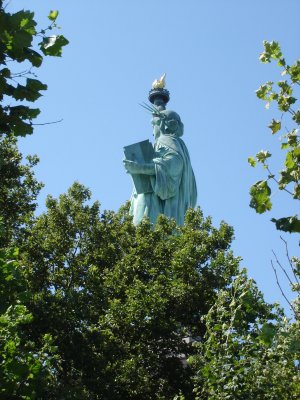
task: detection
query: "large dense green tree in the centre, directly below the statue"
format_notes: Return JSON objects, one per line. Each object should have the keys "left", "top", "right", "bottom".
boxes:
{"left": 17, "top": 183, "right": 248, "bottom": 400}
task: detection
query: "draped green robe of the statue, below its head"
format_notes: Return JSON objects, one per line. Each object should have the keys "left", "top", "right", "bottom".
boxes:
{"left": 130, "top": 135, "right": 197, "bottom": 225}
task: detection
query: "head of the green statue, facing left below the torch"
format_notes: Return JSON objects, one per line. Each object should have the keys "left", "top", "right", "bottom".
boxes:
{"left": 152, "top": 110, "right": 184, "bottom": 139}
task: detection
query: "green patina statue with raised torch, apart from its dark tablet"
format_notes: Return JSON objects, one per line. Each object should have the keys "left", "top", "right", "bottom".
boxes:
{"left": 123, "top": 75, "right": 197, "bottom": 225}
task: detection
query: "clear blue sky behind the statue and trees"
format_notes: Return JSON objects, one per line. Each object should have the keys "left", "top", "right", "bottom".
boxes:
{"left": 9, "top": 0, "right": 300, "bottom": 312}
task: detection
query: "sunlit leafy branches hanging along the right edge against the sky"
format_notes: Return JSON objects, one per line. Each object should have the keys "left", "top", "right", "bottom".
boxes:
{"left": 248, "top": 41, "right": 300, "bottom": 232}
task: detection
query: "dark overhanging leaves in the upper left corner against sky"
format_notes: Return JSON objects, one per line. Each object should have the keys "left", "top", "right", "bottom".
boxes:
{"left": 0, "top": 1, "right": 68, "bottom": 136}
